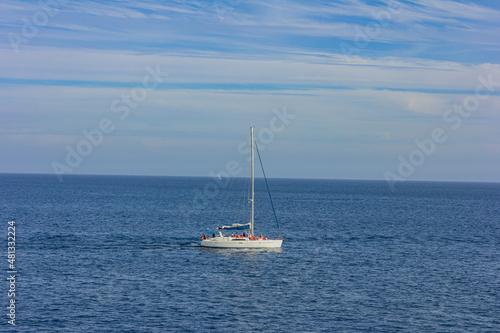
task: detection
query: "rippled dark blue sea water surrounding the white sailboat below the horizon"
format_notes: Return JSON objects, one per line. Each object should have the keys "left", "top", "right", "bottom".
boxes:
{"left": 0, "top": 174, "right": 500, "bottom": 332}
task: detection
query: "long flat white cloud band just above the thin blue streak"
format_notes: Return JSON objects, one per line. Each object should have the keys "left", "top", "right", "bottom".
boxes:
{"left": 0, "top": 47, "right": 500, "bottom": 91}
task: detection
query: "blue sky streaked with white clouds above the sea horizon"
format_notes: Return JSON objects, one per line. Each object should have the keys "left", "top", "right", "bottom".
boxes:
{"left": 0, "top": 0, "right": 500, "bottom": 183}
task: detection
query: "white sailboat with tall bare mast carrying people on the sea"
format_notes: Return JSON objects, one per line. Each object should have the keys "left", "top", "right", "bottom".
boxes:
{"left": 200, "top": 127, "right": 283, "bottom": 249}
